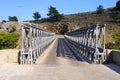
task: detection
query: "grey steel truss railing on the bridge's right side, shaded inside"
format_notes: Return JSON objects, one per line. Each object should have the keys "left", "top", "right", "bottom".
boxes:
{"left": 64, "top": 24, "right": 106, "bottom": 64}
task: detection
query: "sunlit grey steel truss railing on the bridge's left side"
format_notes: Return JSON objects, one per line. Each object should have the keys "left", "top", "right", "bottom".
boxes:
{"left": 20, "top": 25, "right": 55, "bottom": 64}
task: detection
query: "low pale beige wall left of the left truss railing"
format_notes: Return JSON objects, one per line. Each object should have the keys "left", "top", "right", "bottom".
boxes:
{"left": 0, "top": 49, "right": 19, "bottom": 64}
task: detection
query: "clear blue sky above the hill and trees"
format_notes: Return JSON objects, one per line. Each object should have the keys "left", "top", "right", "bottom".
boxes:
{"left": 0, "top": 0, "right": 118, "bottom": 21}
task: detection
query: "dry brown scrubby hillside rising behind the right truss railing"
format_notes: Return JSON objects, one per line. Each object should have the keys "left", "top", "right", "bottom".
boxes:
{"left": 62, "top": 8, "right": 120, "bottom": 42}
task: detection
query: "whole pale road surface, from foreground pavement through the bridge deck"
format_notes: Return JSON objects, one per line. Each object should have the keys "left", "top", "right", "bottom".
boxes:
{"left": 0, "top": 36, "right": 120, "bottom": 80}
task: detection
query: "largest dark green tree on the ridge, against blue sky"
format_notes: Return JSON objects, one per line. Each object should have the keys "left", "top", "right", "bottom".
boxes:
{"left": 47, "top": 6, "right": 63, "bottom": 22}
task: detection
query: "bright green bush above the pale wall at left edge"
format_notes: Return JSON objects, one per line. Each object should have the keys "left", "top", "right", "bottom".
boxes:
{"left": 0, "top": 32, "right": 20, "bottom": 49}
